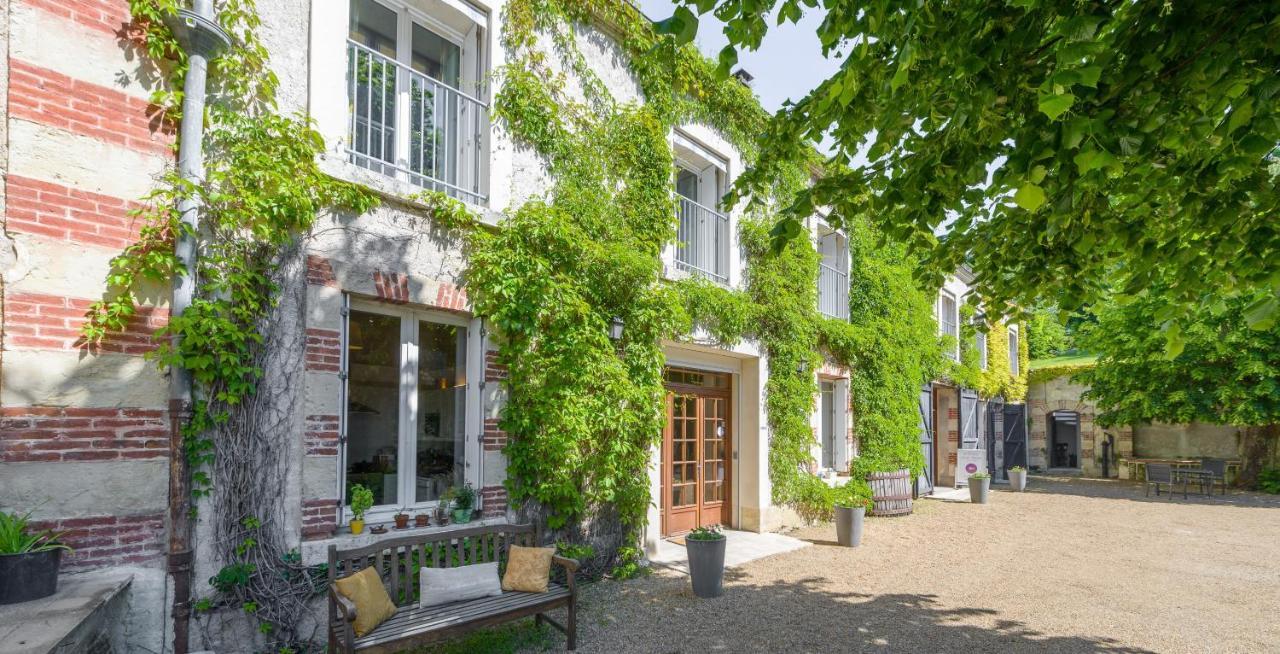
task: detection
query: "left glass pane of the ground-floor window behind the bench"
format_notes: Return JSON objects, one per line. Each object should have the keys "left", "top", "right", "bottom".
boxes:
{"left": 347, "top": 311, "right": 401, "bottom": 504}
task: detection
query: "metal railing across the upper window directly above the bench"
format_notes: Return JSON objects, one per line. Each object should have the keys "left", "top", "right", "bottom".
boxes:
{"left": 347, "top": 41, "right": 489, "bottom": 205}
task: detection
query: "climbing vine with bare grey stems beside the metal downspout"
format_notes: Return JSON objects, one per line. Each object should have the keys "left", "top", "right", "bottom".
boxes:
{"left": 84, "top": 0, "right": 375, "bottom": 651}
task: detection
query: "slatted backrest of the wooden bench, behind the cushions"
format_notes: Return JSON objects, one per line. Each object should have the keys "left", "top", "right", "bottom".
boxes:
{"left": 329, "top": 525, "right": 538, "bottom": 607}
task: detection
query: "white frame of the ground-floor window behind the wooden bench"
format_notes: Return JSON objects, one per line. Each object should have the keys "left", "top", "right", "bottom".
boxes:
{"left": 338, "top": 299, "right": 484, "bottom": 525}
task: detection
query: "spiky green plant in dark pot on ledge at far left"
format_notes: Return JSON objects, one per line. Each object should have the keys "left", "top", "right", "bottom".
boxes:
{"left": 0, "top": 511, "right": 72, "bottom": 604}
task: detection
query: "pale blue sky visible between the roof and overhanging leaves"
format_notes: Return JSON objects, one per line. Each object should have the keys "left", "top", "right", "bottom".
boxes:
{"left": 639, "top": 0, "right": 840, "bottom": 111}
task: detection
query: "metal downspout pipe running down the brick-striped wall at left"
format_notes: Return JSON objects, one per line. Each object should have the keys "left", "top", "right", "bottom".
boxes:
{"left": 166, "top": 0, "right": 230, "bottom": 654}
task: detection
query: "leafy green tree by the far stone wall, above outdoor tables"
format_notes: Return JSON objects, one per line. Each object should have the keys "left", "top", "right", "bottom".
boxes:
{"left": 1076, "top": 288, "right": 1280, "bottom": 479}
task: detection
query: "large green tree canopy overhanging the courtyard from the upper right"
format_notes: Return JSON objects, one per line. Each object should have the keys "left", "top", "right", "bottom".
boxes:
{"left": 658, "top": 0, "right": 1280, "bottom": 328}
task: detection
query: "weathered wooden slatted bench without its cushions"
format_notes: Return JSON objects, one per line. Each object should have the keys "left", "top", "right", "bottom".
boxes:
{"left": 329, "top": 525, "right": 579, "bottom": 653}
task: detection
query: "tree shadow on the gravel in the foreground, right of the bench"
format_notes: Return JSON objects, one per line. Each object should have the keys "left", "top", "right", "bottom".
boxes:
{"left": 553, "top": 570, "right": 1151, "bottom": 654}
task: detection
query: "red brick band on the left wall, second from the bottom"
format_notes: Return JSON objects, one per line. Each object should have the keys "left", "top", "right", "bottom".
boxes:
{"left": 0, "top": 407, "right": 169, "bottom": 462}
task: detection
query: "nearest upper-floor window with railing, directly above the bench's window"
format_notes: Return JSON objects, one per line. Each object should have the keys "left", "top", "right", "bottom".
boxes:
{"left": 347, "top": 0, "right": 489, "bottom": 203}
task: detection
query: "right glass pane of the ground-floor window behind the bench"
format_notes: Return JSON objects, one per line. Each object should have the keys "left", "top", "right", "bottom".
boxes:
{"left": 415, "top": 321, "right": 467, "bottom": 502}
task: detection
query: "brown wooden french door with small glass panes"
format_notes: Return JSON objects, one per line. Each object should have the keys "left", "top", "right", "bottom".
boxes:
{"left": 662, "top": 370, "right": 732, "bottom": 536}
